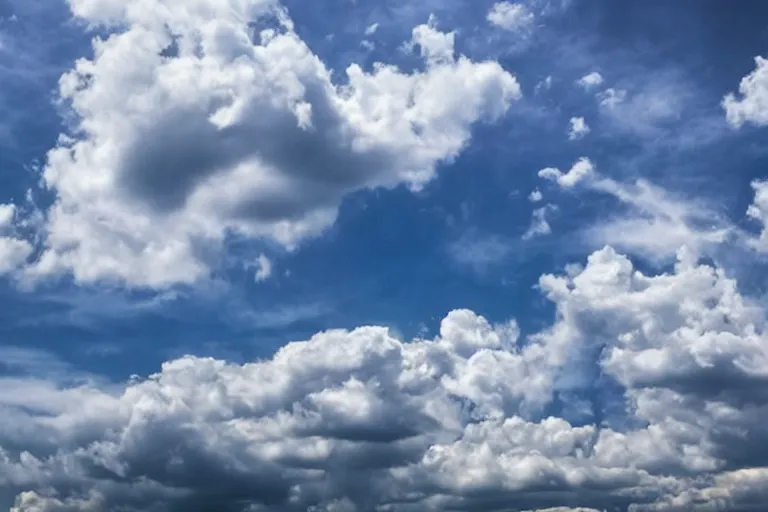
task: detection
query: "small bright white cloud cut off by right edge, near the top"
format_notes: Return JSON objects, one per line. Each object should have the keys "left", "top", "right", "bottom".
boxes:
{"left": 723, "top": 57, "right": 768, "bottom": 128}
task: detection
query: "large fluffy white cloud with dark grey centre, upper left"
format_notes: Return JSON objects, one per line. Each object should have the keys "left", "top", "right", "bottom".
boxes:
{"left": 18, "top": 0, "right": 520, "bottom": 287}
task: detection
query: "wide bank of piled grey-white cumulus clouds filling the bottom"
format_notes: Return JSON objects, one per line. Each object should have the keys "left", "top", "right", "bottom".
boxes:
{"left": 0, "top": 247, "right": 768, "bottom": 512}
